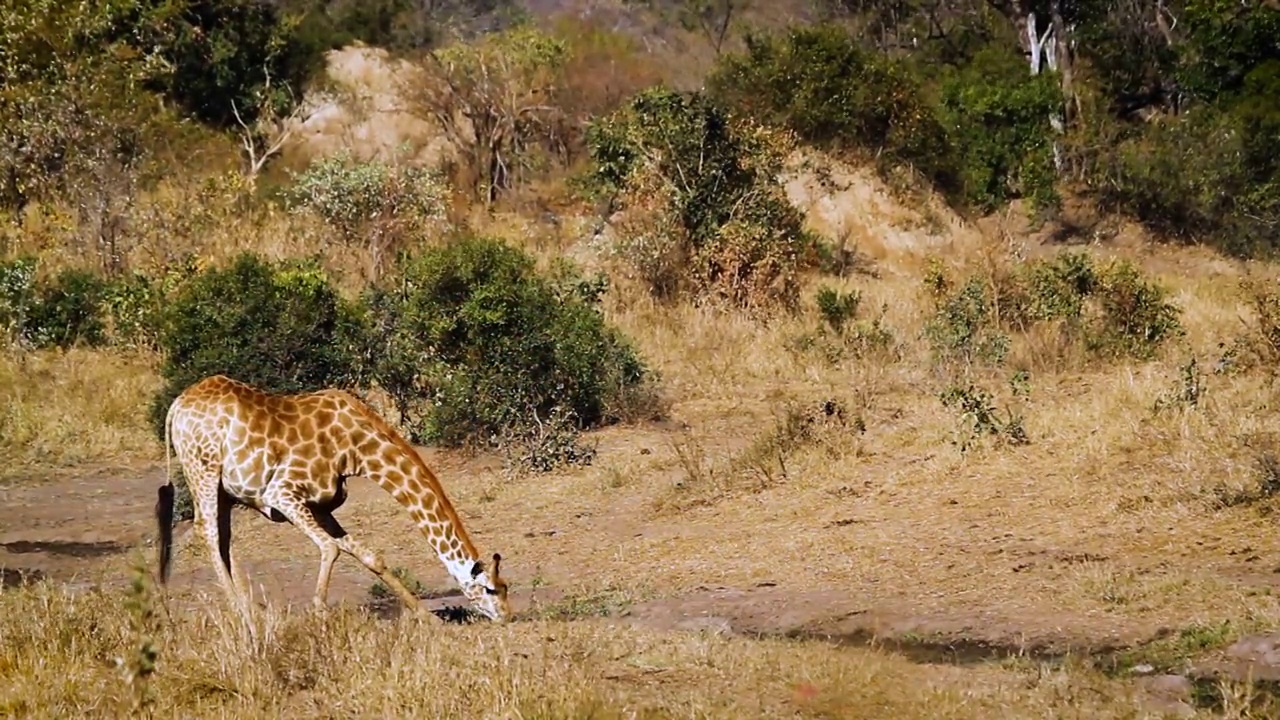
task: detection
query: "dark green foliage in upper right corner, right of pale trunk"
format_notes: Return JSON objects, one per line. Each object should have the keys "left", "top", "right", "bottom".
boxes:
{"left": 1076, "top": 0, "right": 1280, "bottom": 256}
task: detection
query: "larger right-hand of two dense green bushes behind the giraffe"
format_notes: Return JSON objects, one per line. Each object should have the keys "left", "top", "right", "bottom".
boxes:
{"left": 369, "top": 236, "right": 648, "bottom": 458}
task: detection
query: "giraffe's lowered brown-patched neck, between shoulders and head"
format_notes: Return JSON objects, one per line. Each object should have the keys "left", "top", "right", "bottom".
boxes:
{"left": 365, "top": 451, "right": 480, "bottom": 587}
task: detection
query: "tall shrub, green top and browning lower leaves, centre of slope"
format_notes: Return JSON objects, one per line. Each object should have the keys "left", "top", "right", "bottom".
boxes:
{"left": 588, "top": 87, "right": 813, "bottom": 307}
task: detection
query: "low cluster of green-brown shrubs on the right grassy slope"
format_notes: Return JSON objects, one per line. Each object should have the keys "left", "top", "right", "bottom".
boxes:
{"left": 925, "top": 252, "right": 1183, "bottom": 364}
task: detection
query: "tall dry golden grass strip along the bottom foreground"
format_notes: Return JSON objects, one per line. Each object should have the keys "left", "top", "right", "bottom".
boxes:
{"left": 0, "top": 576, "right": 1162, "bottom": 719}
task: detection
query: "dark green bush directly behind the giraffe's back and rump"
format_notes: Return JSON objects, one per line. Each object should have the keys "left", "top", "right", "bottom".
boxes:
{"left": 151, "top": 252, "right": 364, "bottom": 437}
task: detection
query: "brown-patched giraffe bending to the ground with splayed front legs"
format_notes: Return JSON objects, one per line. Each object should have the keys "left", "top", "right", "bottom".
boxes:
{"left": 155, "top": 374, "right": 511, "bottom": 629}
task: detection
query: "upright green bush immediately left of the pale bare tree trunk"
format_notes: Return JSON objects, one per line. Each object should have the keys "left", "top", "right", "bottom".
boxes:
{"left": 941, "top": 46, "right": 1062, "bottom": 211}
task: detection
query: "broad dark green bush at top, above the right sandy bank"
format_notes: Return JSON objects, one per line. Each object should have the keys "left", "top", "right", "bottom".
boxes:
{"left": 708, "top": 24, "right": 948, "bottom": 184}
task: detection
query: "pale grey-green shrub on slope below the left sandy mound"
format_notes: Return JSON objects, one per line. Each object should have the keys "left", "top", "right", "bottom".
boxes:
{"left": 287, "top": 150, "right": 449, "bottom": 278}
